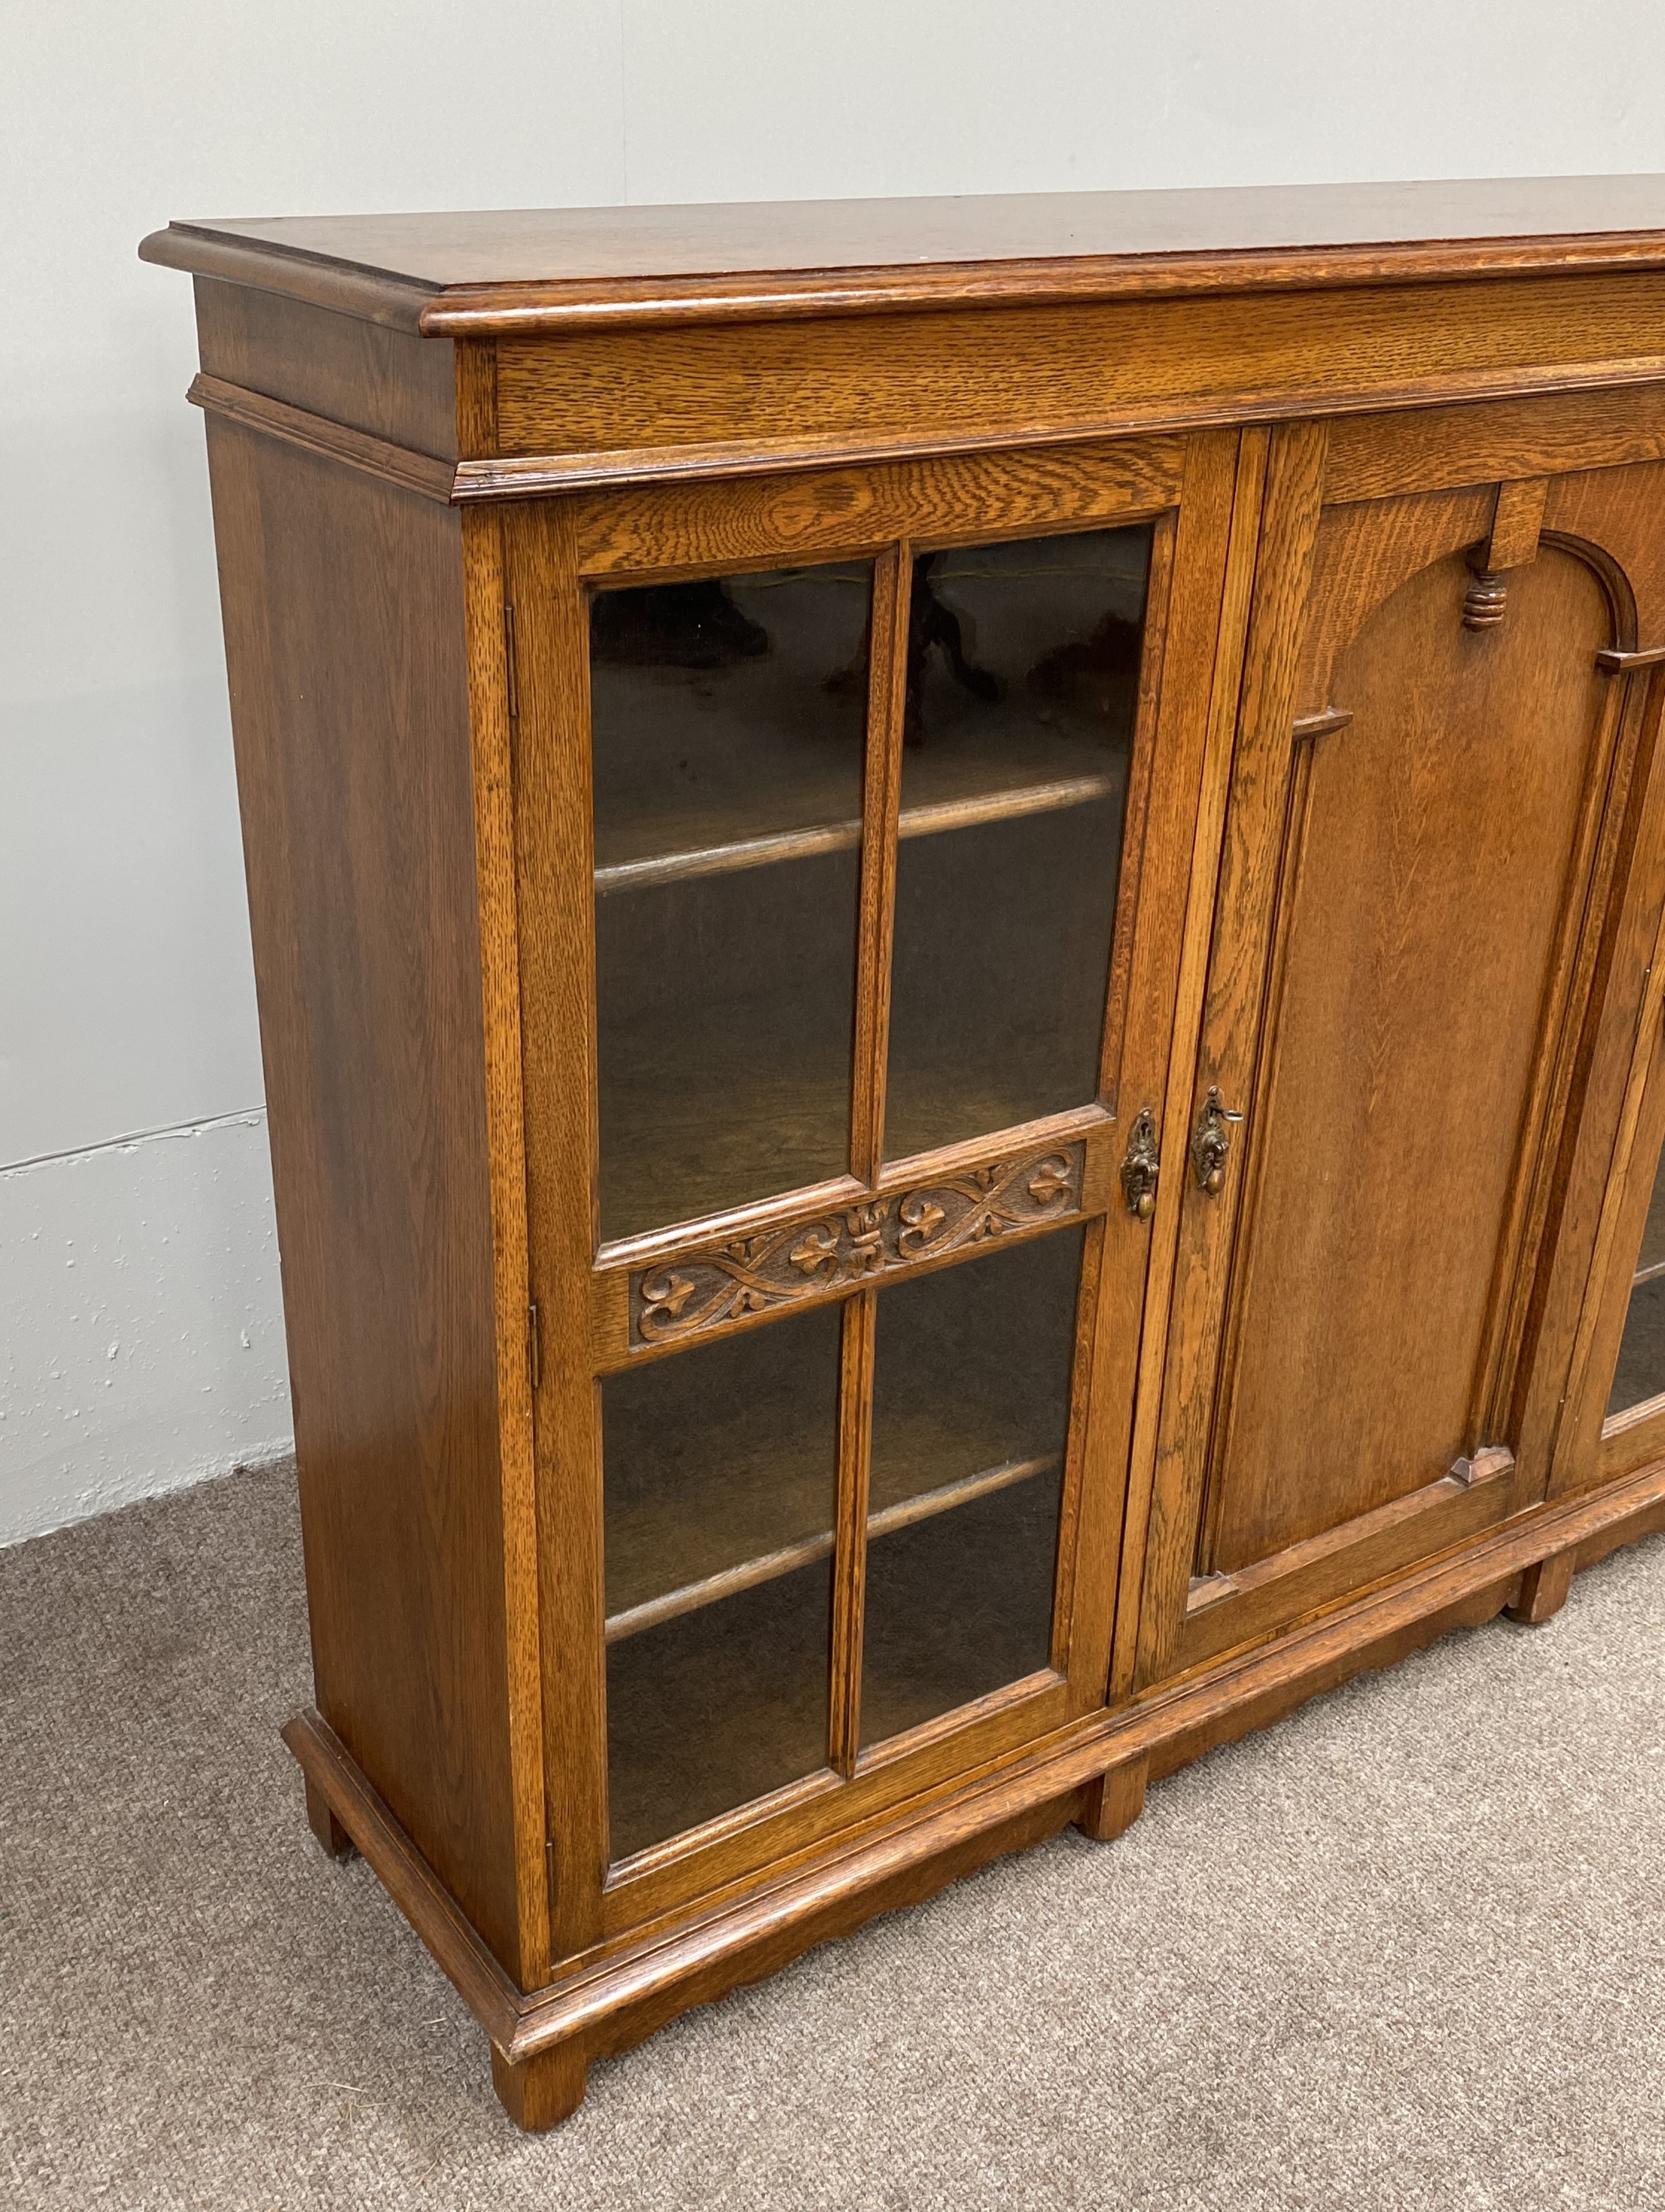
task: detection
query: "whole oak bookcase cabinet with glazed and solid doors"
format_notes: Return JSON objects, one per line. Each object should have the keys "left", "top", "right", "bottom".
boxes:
{"left": 144, "top": 179, "right": 1665, "bottom": 2126}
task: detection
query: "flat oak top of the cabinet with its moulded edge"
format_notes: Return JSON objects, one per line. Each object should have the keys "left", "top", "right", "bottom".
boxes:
{"left": 139, "top": 177, "right": 1665, "bottom": 336}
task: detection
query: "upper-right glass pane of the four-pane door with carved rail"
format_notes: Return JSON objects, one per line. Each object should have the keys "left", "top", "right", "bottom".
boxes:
{"left": 884, "top": 524, "right": 1150, "bottom": 1159}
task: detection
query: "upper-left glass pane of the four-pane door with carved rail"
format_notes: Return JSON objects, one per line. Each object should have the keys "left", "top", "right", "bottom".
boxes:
{"left": 590, "top": 562, "right": 871, "bottom": 1239}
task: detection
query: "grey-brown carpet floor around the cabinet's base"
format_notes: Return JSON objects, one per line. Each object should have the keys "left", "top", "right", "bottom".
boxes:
{"left": 0, "top": 1469, "right": 1665, "bottom": 2212}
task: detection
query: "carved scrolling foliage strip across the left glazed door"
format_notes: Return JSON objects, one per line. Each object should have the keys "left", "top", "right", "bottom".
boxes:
{"left": 630, "top": 1141, "right": 1085, "bottom": 1345}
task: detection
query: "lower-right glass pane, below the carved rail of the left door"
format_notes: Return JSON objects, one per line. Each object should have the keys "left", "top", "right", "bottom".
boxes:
{"left": 862, "top": 1228, "right": 1081, "bottom": 1745}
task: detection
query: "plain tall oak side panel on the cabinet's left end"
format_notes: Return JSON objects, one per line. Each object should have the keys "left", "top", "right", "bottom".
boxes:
{"left": 208, "top": 420, "right": 522, "bottom": 1973}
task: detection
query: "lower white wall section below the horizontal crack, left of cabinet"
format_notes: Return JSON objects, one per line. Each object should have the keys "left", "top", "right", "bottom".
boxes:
{"left": 0, "top": 1113, "right": 294, "bottom": 1544}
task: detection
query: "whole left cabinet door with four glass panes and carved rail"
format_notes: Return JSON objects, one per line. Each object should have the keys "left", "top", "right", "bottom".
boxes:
{"left": 504, "top": 434, "right": 1247, "bottom": 1953}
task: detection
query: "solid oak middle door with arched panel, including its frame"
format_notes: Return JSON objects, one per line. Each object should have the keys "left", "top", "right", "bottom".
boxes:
{"left": 1117, "top": 402, "right": 1665, "bottom": 1690}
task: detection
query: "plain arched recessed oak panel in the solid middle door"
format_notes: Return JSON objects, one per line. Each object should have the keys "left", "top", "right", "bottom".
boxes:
{"left": 1199, "top": 549, "right": 1608, "bottom": 1573}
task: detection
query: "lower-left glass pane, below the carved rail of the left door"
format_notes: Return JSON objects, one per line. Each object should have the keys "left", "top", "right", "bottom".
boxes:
{"left": 601, "top": 1308, "right": 840, "bottom": 1858}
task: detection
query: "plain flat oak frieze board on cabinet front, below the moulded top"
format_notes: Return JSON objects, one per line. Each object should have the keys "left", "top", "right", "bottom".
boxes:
{"left": 497, "top": 272, "right": 1665, "bottom": 467}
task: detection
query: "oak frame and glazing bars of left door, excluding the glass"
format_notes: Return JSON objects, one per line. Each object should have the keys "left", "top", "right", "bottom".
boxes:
{"left": 502, "top": 431, "right": 1265, "bottom": 1960}
